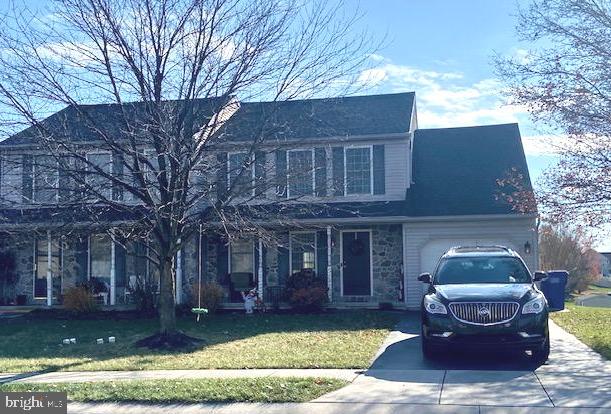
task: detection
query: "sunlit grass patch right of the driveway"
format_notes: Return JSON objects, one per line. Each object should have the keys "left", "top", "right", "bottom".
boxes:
{"left": 551, "top": 303, "right": 611, "bottom": 360}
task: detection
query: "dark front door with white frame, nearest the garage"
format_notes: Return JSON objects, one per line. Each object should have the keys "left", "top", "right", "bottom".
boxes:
{"left": 342, "top": 231, "right": 371, "bottom": 296}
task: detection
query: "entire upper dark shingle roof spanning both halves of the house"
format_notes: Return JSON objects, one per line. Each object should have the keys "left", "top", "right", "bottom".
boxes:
{"left": 0, "top": 92, "right": 414, "bottom": 147}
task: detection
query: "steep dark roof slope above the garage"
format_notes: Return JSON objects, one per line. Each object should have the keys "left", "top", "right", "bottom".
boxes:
{"left": 406, "top": 124, "right": 532, "bottom": 216}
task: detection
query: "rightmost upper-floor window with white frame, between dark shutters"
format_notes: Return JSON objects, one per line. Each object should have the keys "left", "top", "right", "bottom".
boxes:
{"left": 344, "top": 146, "right": 373, "bottom": 194}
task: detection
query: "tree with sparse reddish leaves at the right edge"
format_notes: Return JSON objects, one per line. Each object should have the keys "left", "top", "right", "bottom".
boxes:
{"left": 496, "top": 0, "right": 611, "bottom": 226}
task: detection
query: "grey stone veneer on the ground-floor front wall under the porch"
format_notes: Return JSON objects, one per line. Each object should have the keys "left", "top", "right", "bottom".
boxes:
{"left": 5, "top": 224, "right": 403, "bottom": 304}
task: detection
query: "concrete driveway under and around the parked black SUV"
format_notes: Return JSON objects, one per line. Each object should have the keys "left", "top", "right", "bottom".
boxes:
{"left": 316, "top": 314, "right": 611, "bottom": 412}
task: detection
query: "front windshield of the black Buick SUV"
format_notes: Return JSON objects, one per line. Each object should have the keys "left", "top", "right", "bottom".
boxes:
{"left": 435, "top": 257, "right": 531, "bottom": 285}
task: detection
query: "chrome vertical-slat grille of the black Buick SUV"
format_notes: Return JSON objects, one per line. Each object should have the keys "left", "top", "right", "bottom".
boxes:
{"left": 450, "top": 302, "right": 520, "bottom": 325}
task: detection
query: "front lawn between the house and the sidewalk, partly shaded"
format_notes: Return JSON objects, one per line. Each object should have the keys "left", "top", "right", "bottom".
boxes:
{"left": 0, "top": 311, "right": 398, "bottom": 372}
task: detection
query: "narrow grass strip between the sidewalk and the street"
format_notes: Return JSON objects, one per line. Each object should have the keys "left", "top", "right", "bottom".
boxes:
{"left": 0, "top": 378, "right": 348, "bottom": 403}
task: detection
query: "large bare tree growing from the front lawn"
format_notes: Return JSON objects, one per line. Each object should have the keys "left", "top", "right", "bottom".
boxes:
{"left": 0, "top": 0, "right": 374, "bottom": 342}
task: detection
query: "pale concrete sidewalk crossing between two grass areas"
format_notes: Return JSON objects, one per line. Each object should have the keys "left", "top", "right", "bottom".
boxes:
{"left": 0, "top": 369, "right": 362, "bottom": 384}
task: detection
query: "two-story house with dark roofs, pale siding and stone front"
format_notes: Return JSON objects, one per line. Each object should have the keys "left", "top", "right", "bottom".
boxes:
{"left": 0, "top": 93, "right": 538, "bottom": 309}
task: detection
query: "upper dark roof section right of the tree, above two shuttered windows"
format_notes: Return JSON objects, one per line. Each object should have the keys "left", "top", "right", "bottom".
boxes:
{"left": 216, "top": 92, "right": 415, "bottom": 142}
